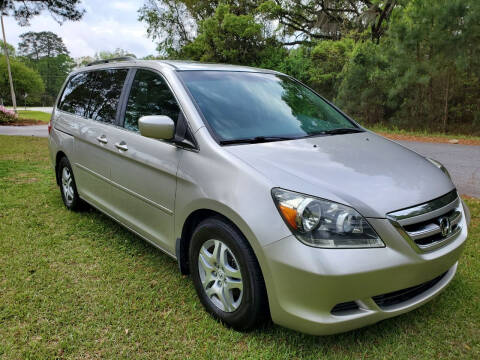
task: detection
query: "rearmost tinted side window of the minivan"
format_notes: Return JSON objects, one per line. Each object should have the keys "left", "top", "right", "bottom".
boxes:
{"left": 58, "top": 72, "right": 93, "bottom": 116}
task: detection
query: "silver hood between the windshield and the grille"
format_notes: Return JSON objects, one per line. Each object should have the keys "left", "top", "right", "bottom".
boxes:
{"left": 224, "top": 132, "right": 455, "bottom": 218}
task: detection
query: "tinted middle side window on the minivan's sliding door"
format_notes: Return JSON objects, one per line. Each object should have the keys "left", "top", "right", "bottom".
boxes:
{"left": 87, "top": 69, "right": 128, "bottom": 124}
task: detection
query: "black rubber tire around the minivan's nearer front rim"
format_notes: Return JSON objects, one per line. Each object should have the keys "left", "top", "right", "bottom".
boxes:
{"left": 189, "top": 217, "right": 270, "bottom": 331}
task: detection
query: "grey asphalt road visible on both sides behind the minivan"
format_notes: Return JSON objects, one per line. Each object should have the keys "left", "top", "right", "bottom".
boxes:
{"left": 0, "top": 125, "right": 480, "bottom": 198}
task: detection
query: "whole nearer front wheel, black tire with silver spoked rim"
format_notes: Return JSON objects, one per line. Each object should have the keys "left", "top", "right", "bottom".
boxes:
{"left": 189, "top": 217, "right": 270, "bottom": 331}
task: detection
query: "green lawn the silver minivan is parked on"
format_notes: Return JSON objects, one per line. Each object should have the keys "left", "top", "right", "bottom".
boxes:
{"left": 0, "top": 136, "right": 480, "bottom": 359}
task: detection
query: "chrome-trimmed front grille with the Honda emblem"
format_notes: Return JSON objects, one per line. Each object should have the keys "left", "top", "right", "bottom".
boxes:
{"left": 387, "top": 190, "right": 462, "bottom": 251}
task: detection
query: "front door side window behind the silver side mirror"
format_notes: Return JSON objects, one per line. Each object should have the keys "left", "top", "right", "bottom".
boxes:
{"left": 123, "top": 69, "right": 180, "bottom": 131}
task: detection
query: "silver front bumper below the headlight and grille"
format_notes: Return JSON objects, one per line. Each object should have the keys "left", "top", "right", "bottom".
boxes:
{"left": 264, "top": 214, "right": 467, "bottom": 335}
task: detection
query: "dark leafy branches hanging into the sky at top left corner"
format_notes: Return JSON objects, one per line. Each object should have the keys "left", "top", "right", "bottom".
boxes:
{"left": 0, "top": 0, "right": 85, "bottom": 26}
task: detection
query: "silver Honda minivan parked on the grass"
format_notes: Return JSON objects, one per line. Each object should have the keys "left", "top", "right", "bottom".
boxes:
{"left": 49, "top": 59, "right": 470, "bottom": 334}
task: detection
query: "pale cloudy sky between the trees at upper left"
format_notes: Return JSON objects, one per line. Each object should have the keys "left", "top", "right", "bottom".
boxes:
{"left": 4, "top": 0, "right": 156, "bottom": 58}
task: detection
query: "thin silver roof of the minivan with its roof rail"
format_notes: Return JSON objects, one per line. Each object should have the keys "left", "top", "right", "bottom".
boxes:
{"left": 77, "top": 59, "right": 277, "bottom": 73}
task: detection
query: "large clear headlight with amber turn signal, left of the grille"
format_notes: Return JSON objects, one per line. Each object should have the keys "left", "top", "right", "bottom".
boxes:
{"left": 272, "top": 188, "right": 385, "bottom": 248}
